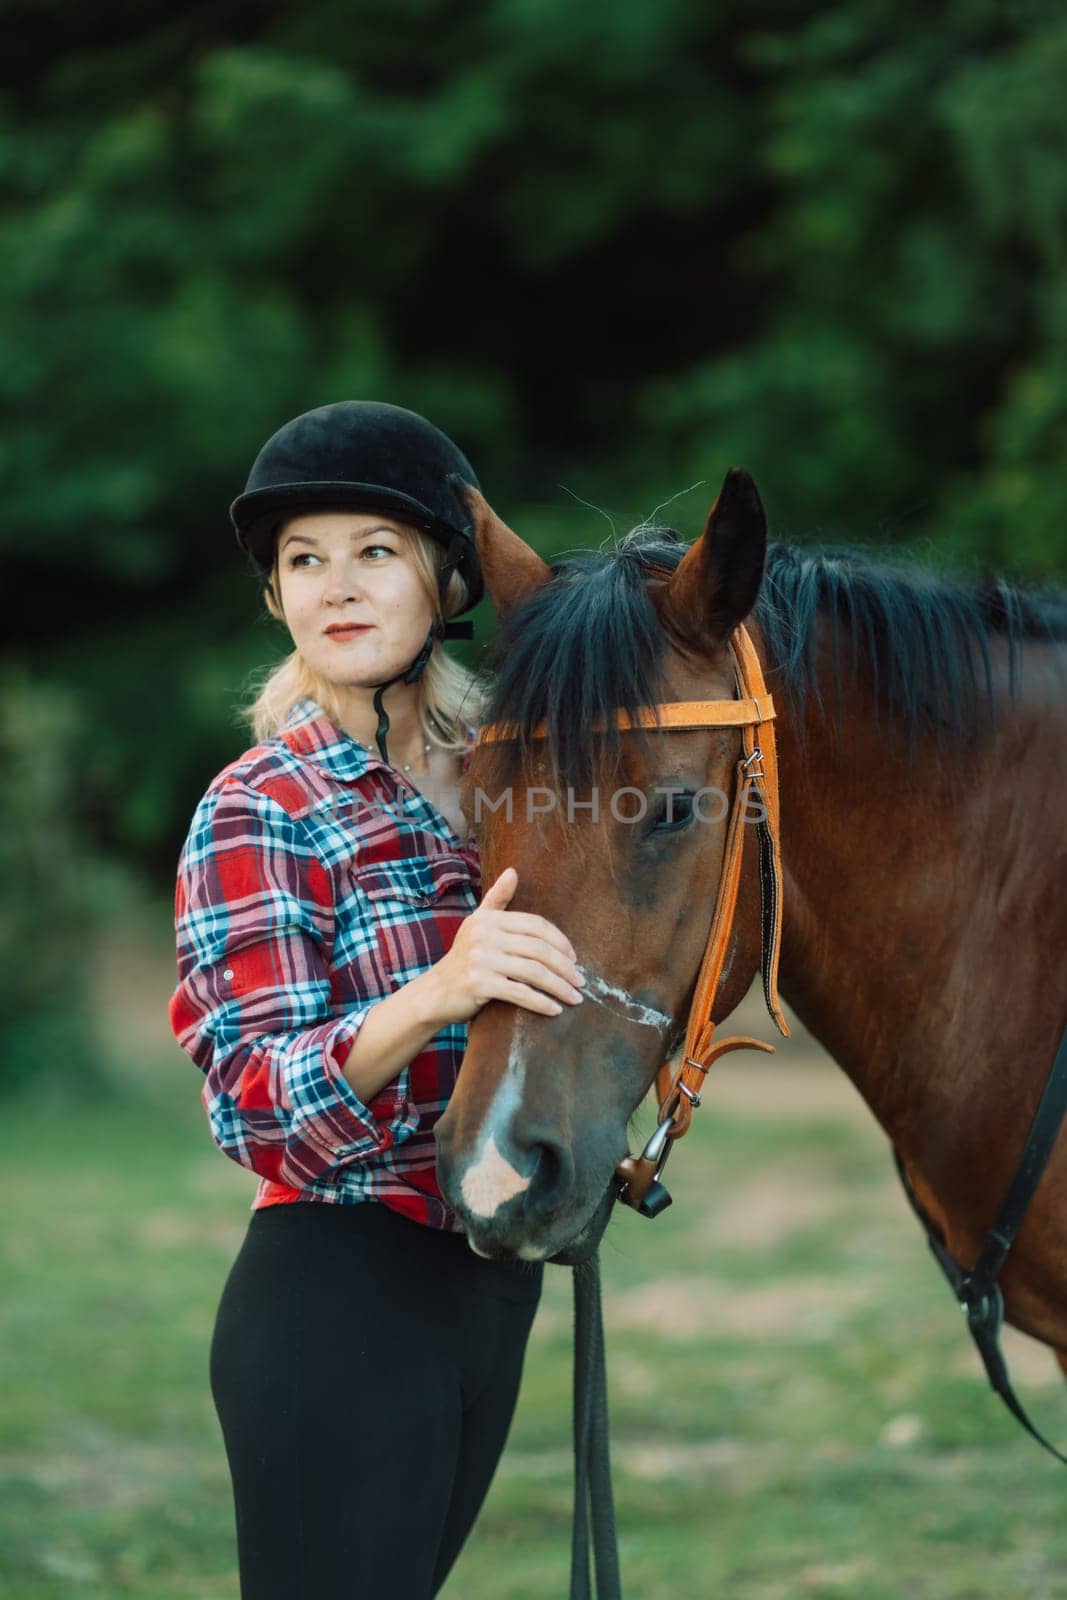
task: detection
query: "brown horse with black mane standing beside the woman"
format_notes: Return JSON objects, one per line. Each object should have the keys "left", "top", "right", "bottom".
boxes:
{"left": 438, "top": 470, "right": 1067, "bottom": 1371}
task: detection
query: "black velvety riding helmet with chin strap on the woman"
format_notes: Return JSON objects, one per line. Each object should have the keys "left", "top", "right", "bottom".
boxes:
{"left": 230, "top": 400, "right": 485, "bottom": 760}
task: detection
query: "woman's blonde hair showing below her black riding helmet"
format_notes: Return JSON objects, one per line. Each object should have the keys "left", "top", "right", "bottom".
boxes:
{"left": 238, "top": 523, "right": 486, "bottom": 750}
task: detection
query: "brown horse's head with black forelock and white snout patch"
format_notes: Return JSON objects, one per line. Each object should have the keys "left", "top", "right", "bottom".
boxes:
{"left": 437, "top": 469, "right": 777, "bottom": 1261}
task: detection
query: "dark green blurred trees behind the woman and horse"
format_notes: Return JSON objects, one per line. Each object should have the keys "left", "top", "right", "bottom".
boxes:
{"left": 0, "top": 0, "right": 1067, "bottom": 885}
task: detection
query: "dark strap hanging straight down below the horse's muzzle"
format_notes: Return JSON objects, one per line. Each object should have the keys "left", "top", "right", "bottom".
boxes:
{"left": 571, "top": 1254, "right": 622, "bottom": 1600}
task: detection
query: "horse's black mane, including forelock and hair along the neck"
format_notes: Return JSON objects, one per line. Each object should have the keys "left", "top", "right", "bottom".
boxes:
{"left": 485, "top": 523, "right": 1067, "bottom": 789}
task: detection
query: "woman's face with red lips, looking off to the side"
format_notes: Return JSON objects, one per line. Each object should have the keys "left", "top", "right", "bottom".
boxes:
{"left": 277, "top": 510, "right": 434, "bottom": 688}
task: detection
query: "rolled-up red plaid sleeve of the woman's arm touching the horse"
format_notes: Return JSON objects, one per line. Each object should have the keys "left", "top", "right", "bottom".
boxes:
{"left": 170, "top": 779, "right": 418, "bottom": 1187}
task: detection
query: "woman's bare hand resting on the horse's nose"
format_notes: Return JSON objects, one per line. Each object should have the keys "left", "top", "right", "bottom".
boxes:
{"left": 424, "top": 867, "right": 584, "bottom": 1022}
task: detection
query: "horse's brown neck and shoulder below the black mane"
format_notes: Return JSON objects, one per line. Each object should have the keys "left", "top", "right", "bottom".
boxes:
{"left": 768, "top": 620, "right": 1067, "bottom": 1350}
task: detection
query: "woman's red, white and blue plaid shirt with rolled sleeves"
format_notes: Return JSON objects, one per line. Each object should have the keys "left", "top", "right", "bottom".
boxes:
{"left": 168, "top": 699, "right": 482, "bottom": 1230}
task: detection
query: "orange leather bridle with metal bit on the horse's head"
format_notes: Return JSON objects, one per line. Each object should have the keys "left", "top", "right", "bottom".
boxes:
{"left": 478, "top": 626, "right": 789, "bottom": 1216}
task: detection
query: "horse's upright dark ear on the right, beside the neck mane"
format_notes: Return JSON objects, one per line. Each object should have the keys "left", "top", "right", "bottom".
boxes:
{"left": 664, "top": 467, "right": 766, "bottom": 646}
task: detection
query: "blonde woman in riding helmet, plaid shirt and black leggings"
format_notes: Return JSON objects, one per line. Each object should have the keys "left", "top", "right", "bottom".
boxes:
{"left": 170, "top": 402, "right": 581, "bottom": 1600}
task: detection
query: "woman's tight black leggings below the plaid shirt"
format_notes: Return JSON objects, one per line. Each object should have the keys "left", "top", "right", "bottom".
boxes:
{"left": 211, "top": 1202, "right": 542, "bottom": 1600}
